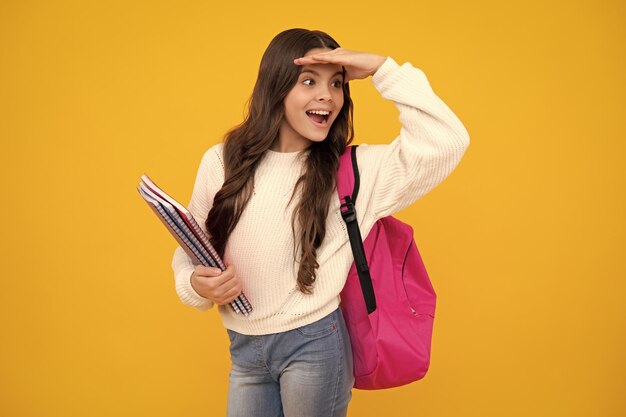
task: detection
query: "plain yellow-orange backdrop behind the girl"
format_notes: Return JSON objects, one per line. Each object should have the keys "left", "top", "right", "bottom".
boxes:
{"left": 0, "top": 0, "right": 626, "bottom": 417}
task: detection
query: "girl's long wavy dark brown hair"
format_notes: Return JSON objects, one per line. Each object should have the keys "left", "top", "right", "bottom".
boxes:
{"left": 205, "top": 29, "right": 354, "bottom": 294}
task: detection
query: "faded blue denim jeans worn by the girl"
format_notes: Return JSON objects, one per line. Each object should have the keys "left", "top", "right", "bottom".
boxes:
{"left": 227, "top": 308, "right": 354, "bottom": 417}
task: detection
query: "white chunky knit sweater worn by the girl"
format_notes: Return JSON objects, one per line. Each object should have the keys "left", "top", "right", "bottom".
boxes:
{"left": 172, "top": 57, "right": 469, "bottom": 335}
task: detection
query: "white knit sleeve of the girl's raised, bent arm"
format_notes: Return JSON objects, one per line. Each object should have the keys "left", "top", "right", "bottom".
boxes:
{"left": 357, "top": 57, "right": 469, "bottom": 222}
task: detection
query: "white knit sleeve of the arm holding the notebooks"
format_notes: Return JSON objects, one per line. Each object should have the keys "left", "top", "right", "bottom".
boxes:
{"left": 172, "top": 144, "right": 224, "bottom": 311}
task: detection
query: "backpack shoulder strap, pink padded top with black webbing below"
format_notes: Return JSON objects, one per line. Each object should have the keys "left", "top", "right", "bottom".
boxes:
{"left": 337, "top": 145, "right": 376, "bottom": 314}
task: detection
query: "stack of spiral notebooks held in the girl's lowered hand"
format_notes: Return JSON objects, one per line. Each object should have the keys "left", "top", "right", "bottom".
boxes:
{"left": 137, "top": 174, "right": 252, "bottom": 316}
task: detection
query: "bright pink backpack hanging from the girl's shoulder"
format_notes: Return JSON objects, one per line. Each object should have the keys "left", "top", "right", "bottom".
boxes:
{"left": 337, "top": 146, "right": 436, "bottom": 389}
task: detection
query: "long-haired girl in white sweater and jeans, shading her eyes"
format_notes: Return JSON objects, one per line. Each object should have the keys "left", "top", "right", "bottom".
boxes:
{"left": 172, "top": 29, "right": 469, "bottom": 417}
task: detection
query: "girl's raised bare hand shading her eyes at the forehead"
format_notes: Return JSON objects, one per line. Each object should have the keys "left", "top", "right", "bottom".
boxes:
{"left": 293, "top": 48, "right": 387, "bottom": 82}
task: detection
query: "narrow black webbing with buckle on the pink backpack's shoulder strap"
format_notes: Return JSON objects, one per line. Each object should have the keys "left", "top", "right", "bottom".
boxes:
{"left": 341, "top": 145, "right": 376, "bottom": 314}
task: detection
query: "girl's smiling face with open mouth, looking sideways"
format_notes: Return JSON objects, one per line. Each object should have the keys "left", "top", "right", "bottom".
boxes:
{"left": 274, "top": 48, "right": 343, "bottom": 152}
